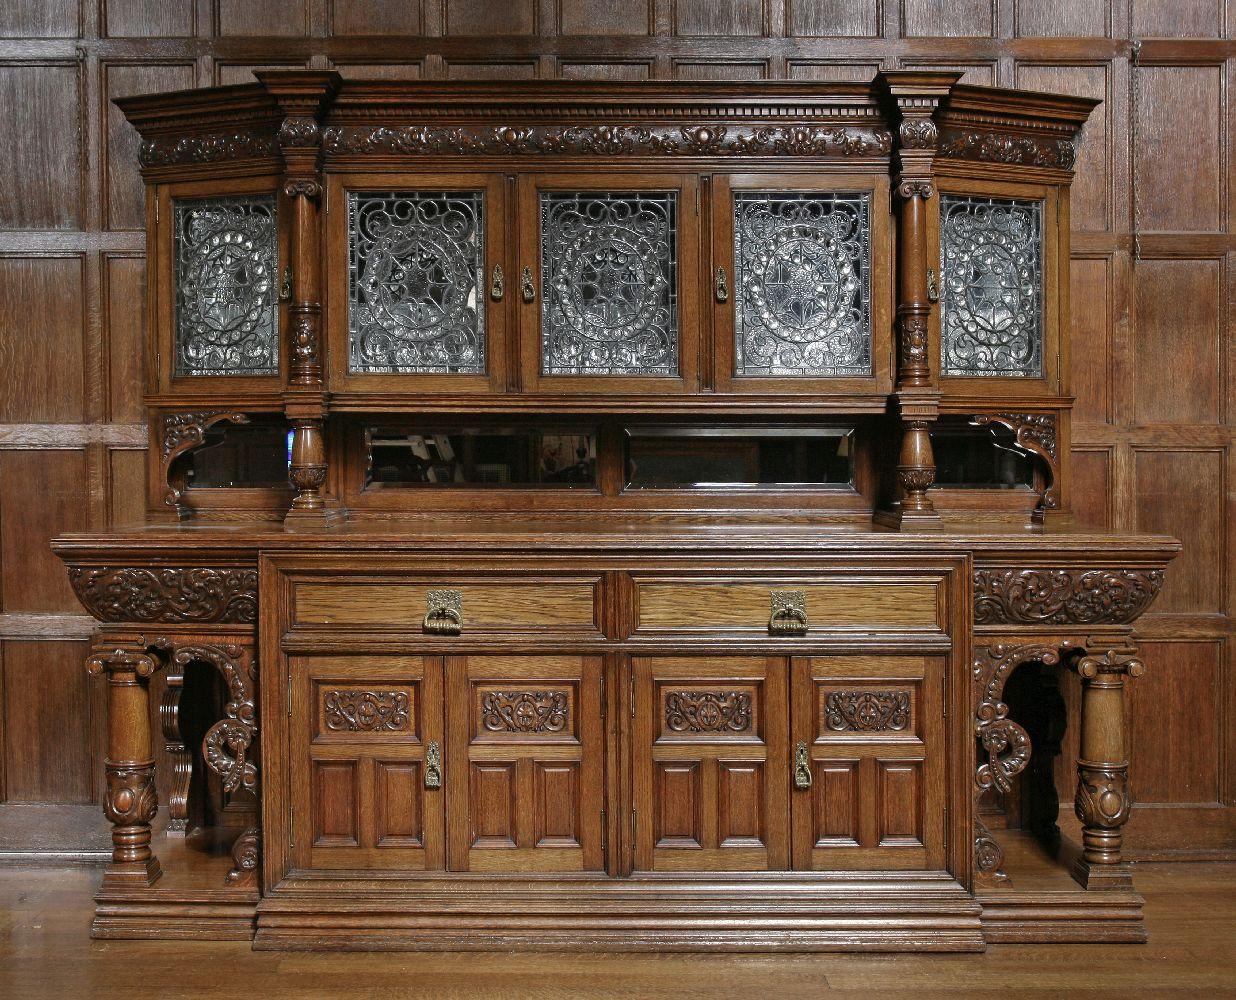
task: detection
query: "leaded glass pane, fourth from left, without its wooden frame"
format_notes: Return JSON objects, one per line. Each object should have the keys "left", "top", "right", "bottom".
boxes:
{"left": 734, "top": 192, "right": 871, "bottom": 378}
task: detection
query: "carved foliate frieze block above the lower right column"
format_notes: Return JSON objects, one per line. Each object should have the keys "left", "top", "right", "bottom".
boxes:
{"left": 974, "top": 567, "right": 1163, "bottom": 625}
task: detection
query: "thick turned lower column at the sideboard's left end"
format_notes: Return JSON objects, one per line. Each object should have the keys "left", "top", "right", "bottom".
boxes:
{"left": 87, "top": 637, "right": 162, "bottom": 886}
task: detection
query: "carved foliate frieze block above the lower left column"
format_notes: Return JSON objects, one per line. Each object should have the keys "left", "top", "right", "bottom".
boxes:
{"left": 69, "top": 566, "right": 257, "bottom": 624}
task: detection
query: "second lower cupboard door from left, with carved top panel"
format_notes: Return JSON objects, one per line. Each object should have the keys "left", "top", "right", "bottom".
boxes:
{"left": 446, "top": 655, "right": 604, "bottom": 871}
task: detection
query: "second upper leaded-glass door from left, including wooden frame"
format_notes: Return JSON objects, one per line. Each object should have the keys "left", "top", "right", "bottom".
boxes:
{"left": 328, "top": 174, "right": 518, "bottom": 393}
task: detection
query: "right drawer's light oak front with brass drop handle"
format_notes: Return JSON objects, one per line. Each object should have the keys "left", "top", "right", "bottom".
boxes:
{"left": 635, "top": 577, "right": 944, "bottom": 635}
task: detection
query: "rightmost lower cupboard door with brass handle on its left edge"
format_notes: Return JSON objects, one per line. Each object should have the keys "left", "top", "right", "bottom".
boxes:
{"left": 790, "top": 655, "right": 946, "bottom": 870}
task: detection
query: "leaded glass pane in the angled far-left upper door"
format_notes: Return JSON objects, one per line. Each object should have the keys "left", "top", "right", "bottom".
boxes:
{"left": 172, "top": 195, "right": 279, "bottom": 376}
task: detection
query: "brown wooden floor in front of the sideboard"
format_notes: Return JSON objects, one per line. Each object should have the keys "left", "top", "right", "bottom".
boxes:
{"left": 0, "top": 864, "right": 1236, "bottom": 1000}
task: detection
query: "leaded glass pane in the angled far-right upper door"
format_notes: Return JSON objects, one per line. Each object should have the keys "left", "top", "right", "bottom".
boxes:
{"left": 939, "top": 195, "right": 1043, "bottom": 378}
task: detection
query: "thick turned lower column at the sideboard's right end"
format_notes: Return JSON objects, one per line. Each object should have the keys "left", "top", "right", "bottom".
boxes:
{"left": 1073, "top": 649, "right": 1146, "bottom": 889}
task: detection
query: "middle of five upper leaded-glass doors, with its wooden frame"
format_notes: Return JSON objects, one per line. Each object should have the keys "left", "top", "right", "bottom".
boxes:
{"left": 514, "top": 174, "right": 700, "bottom": 396}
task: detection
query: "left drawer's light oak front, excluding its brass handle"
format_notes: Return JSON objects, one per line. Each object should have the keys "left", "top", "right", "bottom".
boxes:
{"left": 292, "top": 574, "right": 601, "bottom": 635}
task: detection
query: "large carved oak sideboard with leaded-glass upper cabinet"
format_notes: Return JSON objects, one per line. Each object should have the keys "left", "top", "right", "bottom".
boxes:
{"left": 56, "top": 72, "right": 1177, "bottom": 951}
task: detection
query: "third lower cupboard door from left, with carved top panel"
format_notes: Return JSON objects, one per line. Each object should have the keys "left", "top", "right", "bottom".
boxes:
{"left": 632, "top": 656, "right": 790, "bottom": 871}
